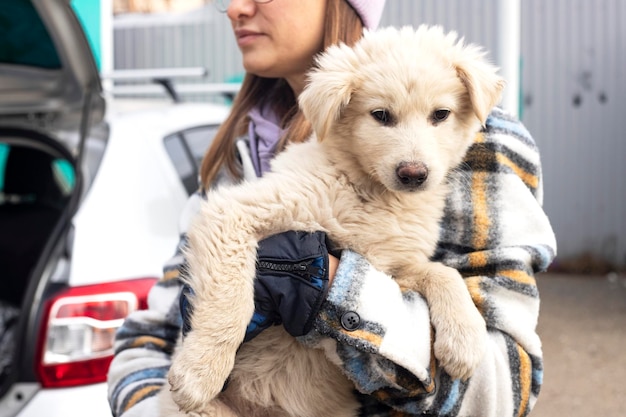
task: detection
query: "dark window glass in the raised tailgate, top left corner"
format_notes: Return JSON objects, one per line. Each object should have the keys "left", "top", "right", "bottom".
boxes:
{"left": 0, "top": 0, "right": 61, "bottom": 69}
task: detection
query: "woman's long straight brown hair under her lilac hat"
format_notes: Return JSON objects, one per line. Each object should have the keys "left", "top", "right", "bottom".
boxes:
{"left": 200, "top": 0, "right": 363, "bottom": 188}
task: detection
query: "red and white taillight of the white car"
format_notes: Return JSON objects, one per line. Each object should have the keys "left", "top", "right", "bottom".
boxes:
{"left": 37, "top": 278, "right": 156, "bottom": 387}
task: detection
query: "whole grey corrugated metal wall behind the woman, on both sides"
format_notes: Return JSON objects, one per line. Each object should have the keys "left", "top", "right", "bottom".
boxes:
{"left": 114, "top": 0, "right": 626, "bottom": 268}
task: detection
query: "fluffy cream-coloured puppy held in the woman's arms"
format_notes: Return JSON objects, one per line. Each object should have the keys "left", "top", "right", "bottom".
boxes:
{"left": 160, "top": 26, "right": 504, "bottom": 417}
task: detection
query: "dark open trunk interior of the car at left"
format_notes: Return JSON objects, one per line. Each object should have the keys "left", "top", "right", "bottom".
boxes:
{"left": 0, "top": 127, "right": 81, "bottom": 393}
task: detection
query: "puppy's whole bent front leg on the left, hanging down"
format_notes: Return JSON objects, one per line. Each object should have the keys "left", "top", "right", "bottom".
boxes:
{"left": 168, "top": 177, "right": 325, "bottom": 412}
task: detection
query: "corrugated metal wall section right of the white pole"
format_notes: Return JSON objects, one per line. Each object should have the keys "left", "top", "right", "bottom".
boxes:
{"left": 522, "top": 0, "right": 626, "bottom": 267}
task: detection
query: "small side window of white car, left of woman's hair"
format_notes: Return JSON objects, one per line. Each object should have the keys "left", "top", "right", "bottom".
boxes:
{"left": 164, "top": 125, "right": 219, "bottom": 194}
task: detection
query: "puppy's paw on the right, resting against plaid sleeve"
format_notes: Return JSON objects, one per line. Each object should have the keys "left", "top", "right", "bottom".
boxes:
{"left": 434, "top": 309, "right": 487, "bottom": 380}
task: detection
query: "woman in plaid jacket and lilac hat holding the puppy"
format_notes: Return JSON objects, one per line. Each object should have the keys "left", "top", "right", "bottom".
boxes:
{"left": 109, "top": 0, "right": 556, "bottom": 417}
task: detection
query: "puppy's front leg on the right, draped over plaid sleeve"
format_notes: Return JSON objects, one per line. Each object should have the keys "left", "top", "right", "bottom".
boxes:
{"left": 397, "top": 262, "right": 487, "bottom": 380}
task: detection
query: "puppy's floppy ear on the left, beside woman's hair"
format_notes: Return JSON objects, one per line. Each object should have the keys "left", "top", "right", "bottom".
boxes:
{"left": 298, "top": 45, "right": 356, "bottom": 141}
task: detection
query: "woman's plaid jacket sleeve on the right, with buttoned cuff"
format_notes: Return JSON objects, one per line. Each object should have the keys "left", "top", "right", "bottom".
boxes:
{"left": 302, "top": 110, "right": 556, "bottom": 417}
